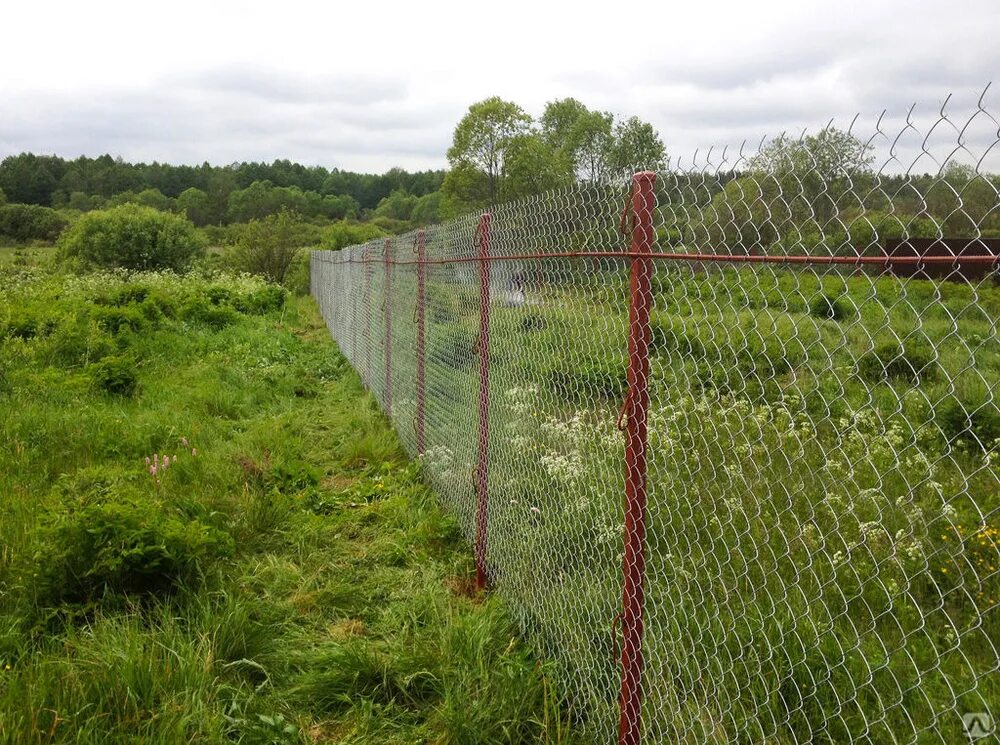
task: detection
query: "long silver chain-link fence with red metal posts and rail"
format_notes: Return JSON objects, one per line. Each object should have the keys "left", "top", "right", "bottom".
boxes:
{"left": 312, "top": 94, "right": 1000, "bottom": 743}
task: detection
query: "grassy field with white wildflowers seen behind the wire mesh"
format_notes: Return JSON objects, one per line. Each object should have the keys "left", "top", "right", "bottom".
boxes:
{"left": 331, "top": 253, "right": 1000, "bottom": 743}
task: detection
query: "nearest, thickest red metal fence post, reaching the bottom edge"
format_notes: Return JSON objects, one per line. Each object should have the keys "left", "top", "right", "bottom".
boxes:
{"left": 618, "top": 171, "right": 656, "bottom": 745}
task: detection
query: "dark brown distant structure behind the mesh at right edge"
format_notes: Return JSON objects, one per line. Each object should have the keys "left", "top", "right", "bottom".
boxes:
{"left": 884, "top": 238, "right": 1000, "bottom": 282}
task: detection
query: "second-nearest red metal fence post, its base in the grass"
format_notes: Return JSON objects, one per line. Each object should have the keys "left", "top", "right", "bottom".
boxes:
{"left": 475, "top": 212, "right": 490, "bottom": 589}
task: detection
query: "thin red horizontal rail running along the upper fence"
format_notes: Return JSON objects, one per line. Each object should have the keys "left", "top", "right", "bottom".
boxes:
{"left": 320, "top": 251, "right": 1000, "bottom": 266}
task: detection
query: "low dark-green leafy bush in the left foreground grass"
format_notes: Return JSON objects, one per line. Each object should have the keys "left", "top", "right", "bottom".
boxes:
{"left": 40, "top": 496, "right": 233, "bottom": 604}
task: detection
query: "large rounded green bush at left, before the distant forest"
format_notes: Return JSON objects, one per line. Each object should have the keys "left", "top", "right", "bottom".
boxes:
{"left": 59, "top": 204, "right": 202, "bottom": 271}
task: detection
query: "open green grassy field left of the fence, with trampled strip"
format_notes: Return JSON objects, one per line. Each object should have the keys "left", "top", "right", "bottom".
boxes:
{"left": 0, "top": 264, "right": 571, "bottom": 743}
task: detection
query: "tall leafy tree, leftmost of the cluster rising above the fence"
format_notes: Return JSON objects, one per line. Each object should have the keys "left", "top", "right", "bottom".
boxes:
{"left": 445, "top": 96, "right": 531, "bottom": 204}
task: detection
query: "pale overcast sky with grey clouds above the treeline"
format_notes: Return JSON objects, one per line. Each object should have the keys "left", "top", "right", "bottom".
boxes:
{"left": 0, "top": 0, "right": 1000, "bottom": 172}
